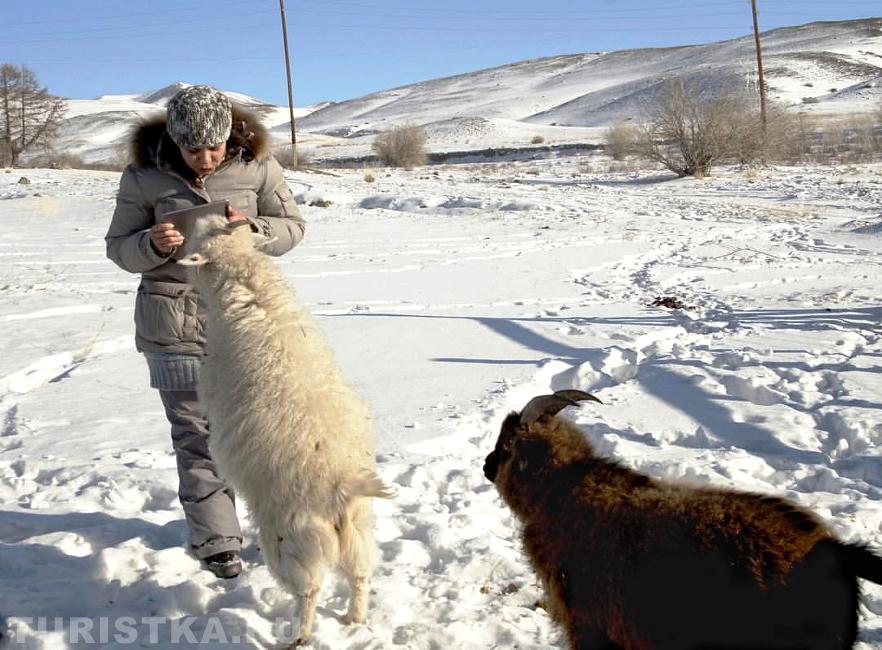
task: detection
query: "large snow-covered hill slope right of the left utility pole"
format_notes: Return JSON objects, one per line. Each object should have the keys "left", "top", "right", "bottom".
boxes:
{"left": 301, "top": 18, "right": 882, "bottom": 136}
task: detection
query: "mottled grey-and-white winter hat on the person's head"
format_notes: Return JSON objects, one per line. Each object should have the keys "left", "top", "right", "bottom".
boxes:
{"left": 165, "top": 86, "right": 233, "bottom": 149}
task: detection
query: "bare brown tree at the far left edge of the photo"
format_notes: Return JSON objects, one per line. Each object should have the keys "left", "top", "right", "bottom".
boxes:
{"left": 0, "top": 63, "right": 65, "bottom": 167}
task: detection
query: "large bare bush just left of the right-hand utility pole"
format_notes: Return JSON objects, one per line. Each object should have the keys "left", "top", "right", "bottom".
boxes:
{"left": 641, "top": 78, "right": 744, "bottom": 177}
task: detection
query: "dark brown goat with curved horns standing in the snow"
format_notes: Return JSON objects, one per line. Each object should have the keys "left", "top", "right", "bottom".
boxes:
{"left": 484, "top": 391, "right": 882, "bottom": 650}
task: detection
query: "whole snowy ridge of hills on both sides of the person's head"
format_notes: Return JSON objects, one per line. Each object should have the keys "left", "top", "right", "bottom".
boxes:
{"left": 48, "top": 18, "right": 882, "bottom": 162}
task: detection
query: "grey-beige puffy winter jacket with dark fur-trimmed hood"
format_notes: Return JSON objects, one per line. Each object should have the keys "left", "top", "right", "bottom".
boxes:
{"left": 105, "top": 107, "right": 305, "bottom": 354}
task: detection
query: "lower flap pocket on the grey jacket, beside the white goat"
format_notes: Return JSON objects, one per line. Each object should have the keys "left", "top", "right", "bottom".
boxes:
{"left": 135, "top": 279, "right": 196, "bottom": 346}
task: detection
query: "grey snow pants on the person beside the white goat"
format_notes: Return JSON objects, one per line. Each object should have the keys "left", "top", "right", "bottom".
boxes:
{"left": 159, "top": 390, "right": 242, "bottom": 559}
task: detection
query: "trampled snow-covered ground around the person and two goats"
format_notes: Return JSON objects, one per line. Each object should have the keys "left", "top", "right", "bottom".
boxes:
{"left": 0, "top": 158, "right": 882, "bottom": 650}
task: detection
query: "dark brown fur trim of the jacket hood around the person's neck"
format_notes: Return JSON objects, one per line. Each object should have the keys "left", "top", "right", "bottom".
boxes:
{"left": 129, "top": 103, "right": 272, "bottom": 169}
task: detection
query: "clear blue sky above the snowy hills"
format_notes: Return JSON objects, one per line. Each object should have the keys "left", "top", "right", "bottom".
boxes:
{"left": 0, "top": 0, "right": 882, "bottom": 106}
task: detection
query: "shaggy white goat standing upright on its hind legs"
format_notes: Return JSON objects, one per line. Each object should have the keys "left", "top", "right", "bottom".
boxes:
{"left": 180, "top": 216, "right": 392, "bottom": 645}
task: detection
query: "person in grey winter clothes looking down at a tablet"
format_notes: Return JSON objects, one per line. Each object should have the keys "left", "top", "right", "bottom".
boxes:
{"left": 105, "top": 86, "right": 305, "bottom": 578}
